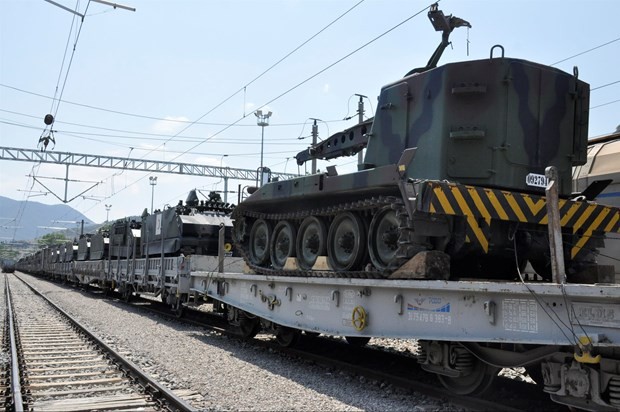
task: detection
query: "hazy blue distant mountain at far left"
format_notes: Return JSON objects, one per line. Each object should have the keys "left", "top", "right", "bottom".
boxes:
{"left": 0, "top": 196, "right": 98, "bottom": 242}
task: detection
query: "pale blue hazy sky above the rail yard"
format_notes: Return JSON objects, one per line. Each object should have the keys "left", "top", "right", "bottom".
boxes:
{"left": 0, "top": 0, "right": 620, "bottom": 235}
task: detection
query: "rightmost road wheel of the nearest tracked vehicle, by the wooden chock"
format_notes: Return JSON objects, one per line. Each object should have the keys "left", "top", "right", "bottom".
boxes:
{"left": 368, "top": 206, "right": 400, "bottom": 270}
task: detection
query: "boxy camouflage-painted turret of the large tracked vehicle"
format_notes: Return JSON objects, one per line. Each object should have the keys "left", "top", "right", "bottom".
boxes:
{"left": 364, "top": 58, "right": 589, "bottom": 195}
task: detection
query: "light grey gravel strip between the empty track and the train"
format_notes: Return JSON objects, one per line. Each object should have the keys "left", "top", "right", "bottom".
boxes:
{"left": 20, "top": 274, "right": 462, "bottom": 411}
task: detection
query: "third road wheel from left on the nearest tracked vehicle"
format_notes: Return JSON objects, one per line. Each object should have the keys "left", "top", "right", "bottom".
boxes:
{"left": 296, "top": 216, "right": 327, "bottom": 270}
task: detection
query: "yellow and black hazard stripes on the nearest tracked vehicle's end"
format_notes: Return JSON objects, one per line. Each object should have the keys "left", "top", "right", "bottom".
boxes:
{"left": 418, "top": 181, "right": 620, "bottom": 259}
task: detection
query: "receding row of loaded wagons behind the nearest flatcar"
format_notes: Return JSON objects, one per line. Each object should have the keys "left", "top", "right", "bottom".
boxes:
{"left": 17, "top": 190, "right": 237, "bottom": 312}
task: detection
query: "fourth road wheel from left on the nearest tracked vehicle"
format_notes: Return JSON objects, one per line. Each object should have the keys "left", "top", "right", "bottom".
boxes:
{"left": 327, "top": 212, "right": 366, "bottom": 271}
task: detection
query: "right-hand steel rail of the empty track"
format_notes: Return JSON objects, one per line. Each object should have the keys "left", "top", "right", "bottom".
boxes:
{"left": 15, "top": 276, "right": 196, "bottom": 412}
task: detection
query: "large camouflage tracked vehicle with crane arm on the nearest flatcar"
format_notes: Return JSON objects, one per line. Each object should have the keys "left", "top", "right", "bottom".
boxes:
{"left": 233, "top": 5, "right": 620, "bottom": 281}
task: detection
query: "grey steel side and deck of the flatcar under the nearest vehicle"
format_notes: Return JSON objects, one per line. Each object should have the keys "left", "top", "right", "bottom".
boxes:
{"left": 190, "top": 272, "right": 620, "bottom": 347}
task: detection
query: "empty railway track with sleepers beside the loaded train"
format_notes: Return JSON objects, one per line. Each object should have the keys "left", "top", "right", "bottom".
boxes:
{"left": 4, "top": 276, "right": 193, "bottom": 411}
